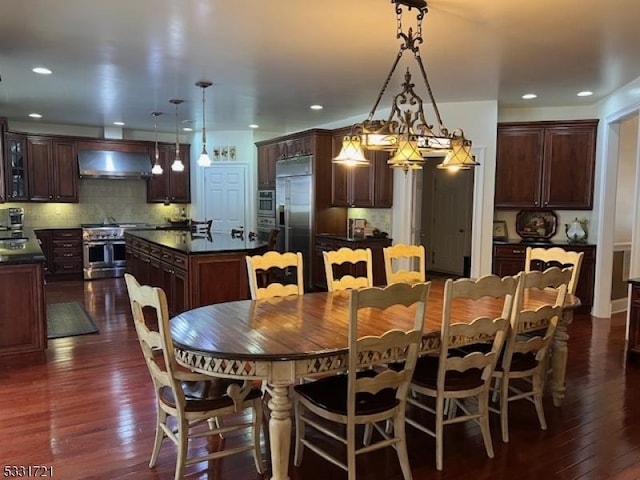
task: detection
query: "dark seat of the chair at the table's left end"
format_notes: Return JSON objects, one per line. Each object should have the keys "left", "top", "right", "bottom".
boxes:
{"left": 160, "top": 379, "right": 262, "bottom": 412}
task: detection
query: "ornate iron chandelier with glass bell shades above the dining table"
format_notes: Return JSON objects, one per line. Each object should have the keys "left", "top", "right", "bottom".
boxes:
{"left": 333, "top": 0, "right": 479, "bottom": 172}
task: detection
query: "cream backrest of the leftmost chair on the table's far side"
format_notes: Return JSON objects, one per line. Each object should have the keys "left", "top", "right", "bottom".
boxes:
{"left": 246, "top": 252, "right": 304, "bottom": 300}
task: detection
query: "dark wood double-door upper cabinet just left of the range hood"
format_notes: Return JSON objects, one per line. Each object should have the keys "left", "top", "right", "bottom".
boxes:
{"left": 27, "top": 136, "right": 78, "bottom": 202}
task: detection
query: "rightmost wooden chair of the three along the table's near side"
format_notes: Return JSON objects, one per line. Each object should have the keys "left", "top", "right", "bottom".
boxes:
{"left": 491, "top": 267, "right": 572, "bottom": 443}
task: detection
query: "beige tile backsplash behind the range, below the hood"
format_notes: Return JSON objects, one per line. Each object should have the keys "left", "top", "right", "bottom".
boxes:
{"left": 13, "top": 179, "right": 189, "bottom": 228}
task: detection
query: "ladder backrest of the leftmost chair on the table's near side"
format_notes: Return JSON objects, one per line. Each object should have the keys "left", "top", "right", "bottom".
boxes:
{"left": 347, "top": 282, "right": 431, "bottom": 416}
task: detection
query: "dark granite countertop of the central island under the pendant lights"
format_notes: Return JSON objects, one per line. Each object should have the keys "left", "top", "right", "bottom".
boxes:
{"left": 125, "top": 230, "right": 267, "bottom": 254}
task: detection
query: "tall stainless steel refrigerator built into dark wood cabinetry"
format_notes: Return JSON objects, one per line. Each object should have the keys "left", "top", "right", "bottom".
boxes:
{"left": 276, "top": 155, "right": 314, "bottom": 286}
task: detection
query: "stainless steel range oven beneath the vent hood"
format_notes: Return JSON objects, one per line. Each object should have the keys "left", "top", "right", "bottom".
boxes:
{"left": 82, "top": 226, "right": 126, "bottom": 280}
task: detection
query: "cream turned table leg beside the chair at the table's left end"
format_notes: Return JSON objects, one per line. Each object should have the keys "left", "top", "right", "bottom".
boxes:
{"left": 268, "top": 386, "right": 291, "bottom": 480}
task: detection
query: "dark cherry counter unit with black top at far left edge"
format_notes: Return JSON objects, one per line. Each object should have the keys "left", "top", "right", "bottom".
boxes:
{"left": 0, "top": 232, "right": 47, "bottom": 367}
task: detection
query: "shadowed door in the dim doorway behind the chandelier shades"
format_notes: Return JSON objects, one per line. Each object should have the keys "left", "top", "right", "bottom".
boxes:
{"left": 421, "top": 162, "right": 473, "bottom": 275}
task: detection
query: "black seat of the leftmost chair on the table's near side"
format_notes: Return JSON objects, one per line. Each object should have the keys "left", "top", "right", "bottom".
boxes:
{"left": 294, "top": 370, "right": 399, "bottom": 415}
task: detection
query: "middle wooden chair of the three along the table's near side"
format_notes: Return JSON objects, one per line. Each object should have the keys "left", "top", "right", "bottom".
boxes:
{"left": 406, "top": 275, "right": 518, "bottom": 470}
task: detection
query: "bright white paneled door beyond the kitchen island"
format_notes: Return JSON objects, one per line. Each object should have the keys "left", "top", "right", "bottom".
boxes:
{"left": 204, "top": 165, "right": 246, "bottom": 233}
